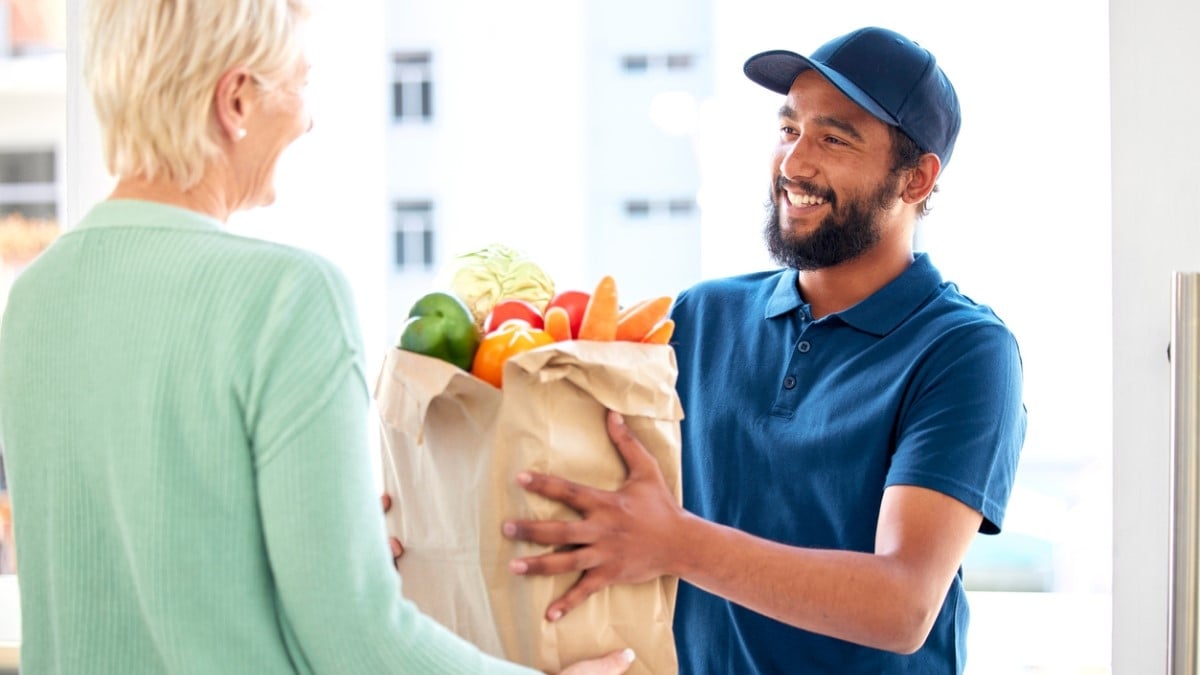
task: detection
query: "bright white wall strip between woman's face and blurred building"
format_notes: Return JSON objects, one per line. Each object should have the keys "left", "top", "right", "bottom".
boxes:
{"left": 230, "top": 0, "right": 389, "bottom": 362}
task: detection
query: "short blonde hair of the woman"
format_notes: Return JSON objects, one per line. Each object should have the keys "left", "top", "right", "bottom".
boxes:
{"left": 83, "top": 0, "right": 308, "bottom": 190}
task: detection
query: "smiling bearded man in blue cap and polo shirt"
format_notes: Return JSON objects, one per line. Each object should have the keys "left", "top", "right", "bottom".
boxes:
{"left": 505, "top": 28, "right": 1026, "bottom": 675}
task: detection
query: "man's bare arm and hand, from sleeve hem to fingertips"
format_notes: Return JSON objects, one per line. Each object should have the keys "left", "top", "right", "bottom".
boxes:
{"left": 505, "top": 413, "right": 983, "bottom": 653}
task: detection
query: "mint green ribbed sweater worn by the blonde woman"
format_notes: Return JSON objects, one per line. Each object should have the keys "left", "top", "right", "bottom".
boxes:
{"left": 0, "top": 201, "right": 533, "bottom": 675}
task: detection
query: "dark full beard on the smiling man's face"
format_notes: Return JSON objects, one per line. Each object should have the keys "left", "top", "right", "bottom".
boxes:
{"left": 763, "top": 175, "right": 898, "bottom": 270}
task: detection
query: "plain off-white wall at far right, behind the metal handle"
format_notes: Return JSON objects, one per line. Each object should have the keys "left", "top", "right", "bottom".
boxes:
{"left": 1104, "top": 0, "right": 1200, "bottom": 674}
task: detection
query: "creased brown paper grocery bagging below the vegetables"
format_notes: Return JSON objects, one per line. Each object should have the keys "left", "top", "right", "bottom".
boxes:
{"left": 376, "top": 341, "right": 683, "bottom": 675}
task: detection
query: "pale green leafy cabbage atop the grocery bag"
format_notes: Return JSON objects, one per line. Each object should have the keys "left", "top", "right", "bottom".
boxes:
{"left": 442, "top": 244, "right": 554, "bottom": 327}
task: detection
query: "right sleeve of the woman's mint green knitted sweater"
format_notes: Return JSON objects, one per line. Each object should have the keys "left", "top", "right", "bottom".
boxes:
{"left": 246, "top": 253, "right": 534, "bottom": 675}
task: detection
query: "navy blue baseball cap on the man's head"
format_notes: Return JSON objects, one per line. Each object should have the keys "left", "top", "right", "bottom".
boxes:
{"left": 742, "top": 28, "right": 962, "bottom": 167}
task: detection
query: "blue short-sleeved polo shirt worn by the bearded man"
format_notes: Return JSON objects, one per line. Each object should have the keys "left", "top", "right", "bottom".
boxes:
{"left": 672, "top": 253, "right": 1025, "bottom": 675}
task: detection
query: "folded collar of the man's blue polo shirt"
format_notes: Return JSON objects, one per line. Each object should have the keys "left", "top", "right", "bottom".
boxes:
{"left": 767, "top": 252, "right": 942, "bottom": 335}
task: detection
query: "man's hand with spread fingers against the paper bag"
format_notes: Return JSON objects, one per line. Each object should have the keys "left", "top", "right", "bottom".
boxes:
{"left": 503, "top": 411, "right": 689, "bottom": 621}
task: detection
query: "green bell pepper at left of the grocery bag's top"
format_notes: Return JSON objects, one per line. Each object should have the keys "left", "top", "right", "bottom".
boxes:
{"left": 397, "top": 291, "right": 480, "bottom": 370}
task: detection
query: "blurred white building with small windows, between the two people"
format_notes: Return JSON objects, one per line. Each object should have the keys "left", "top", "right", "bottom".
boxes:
{"left": 386, "top": 0, "right": 713, "bottom": 333}
